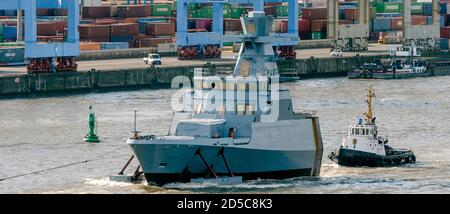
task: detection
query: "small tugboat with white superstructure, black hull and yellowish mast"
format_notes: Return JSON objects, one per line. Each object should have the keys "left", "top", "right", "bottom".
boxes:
{"left": 328, "top": 85, "right": 416, "bottom": 167}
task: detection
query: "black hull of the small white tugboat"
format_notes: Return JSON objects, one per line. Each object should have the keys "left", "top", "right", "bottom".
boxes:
{"left": 328, "top": 148, "right": 416, "bottom": 167}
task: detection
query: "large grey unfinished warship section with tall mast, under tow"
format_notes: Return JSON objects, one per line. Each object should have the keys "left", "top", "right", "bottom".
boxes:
{"left": 127, "top": 11, "right": 323, "bottom": 186}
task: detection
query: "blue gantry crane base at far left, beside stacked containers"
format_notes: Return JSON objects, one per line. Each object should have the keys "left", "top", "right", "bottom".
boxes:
{"left": 0, "top": 0, "right": 80, "bottom": 73}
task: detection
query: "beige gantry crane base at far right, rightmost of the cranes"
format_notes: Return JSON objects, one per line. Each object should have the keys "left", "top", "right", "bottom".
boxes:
{"left": 402, "top": 0, "right": 441, "bottom": 52}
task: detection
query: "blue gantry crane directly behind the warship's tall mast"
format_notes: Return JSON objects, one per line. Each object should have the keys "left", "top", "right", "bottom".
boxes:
{"left": 177, "top": 0, "right": 299, "bottom": 59}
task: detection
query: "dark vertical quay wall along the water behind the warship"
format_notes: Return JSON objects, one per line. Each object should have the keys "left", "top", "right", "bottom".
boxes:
{"left": 0, "top": 55, "right": 383, "bottom": 99}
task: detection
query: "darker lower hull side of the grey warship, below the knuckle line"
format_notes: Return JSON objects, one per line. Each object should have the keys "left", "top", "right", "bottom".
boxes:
{"left": 134, "top": 145, "right": 315, "bottom": 186}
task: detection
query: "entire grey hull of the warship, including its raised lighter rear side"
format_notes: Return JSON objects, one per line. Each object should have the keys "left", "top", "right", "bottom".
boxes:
{"left": 128, "top": 118, "right": 323, "bottom": 186}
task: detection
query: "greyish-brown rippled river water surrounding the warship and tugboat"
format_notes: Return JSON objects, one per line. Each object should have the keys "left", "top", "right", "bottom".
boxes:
{"left": 0, "top": 77, "right": 450, "bottom": 193}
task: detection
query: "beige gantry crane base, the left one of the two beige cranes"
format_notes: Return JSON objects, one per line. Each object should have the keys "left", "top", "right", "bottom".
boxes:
{"left": 327, "top": 0, "right": 369, "bottom": 51}
